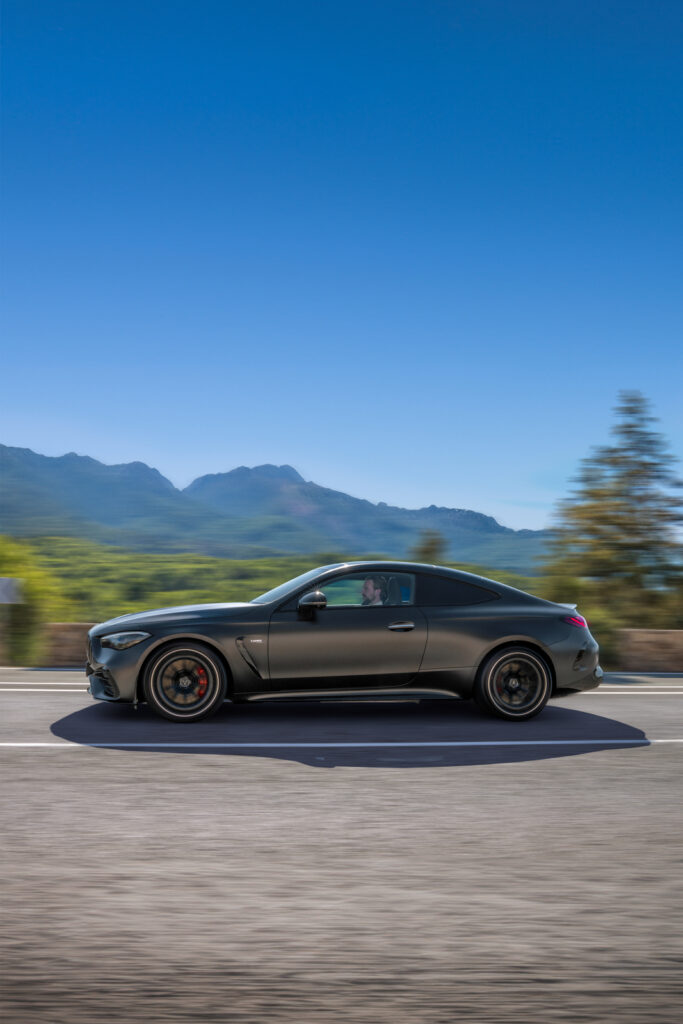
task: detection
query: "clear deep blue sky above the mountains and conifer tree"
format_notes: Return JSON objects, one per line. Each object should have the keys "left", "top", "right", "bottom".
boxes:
{"left": 0, "top": 0, "right": 683, "bottom": 527}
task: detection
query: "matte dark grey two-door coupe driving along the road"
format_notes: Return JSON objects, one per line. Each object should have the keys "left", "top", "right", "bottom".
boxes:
{"left": 86, "top": 562, "right": 602, "bottom": 722}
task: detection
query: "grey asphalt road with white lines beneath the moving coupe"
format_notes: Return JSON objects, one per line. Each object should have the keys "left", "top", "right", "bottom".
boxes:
{"left": 0, "top": 670, "right": 683, "bottom": 1024}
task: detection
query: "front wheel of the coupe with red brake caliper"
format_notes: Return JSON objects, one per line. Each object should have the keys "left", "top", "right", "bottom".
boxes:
{"left": 142, "top": 643, "right": 227, "bottom": 722}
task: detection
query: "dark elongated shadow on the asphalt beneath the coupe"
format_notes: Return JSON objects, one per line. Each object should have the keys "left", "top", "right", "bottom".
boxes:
{"left": 51, "top": 699, "right": 648, "bottom": 768}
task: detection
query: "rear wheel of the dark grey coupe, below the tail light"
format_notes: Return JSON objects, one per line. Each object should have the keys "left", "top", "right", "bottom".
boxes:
{"left": 474, "top": 646, "right": 553, "bottom": 722}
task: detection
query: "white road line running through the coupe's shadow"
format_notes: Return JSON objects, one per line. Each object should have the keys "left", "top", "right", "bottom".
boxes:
{"left": 0, "top": 738, "right": 683, "bottom": 751}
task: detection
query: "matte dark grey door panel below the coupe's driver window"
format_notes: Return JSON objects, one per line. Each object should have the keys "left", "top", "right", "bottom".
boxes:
{"left": 268, "top": 605, "right": 427, "bottom": 688}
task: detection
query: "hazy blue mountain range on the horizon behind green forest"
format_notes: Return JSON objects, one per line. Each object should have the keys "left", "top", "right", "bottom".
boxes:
{"left": 0, "top": 444, "right": 547, "bottom": 572}
